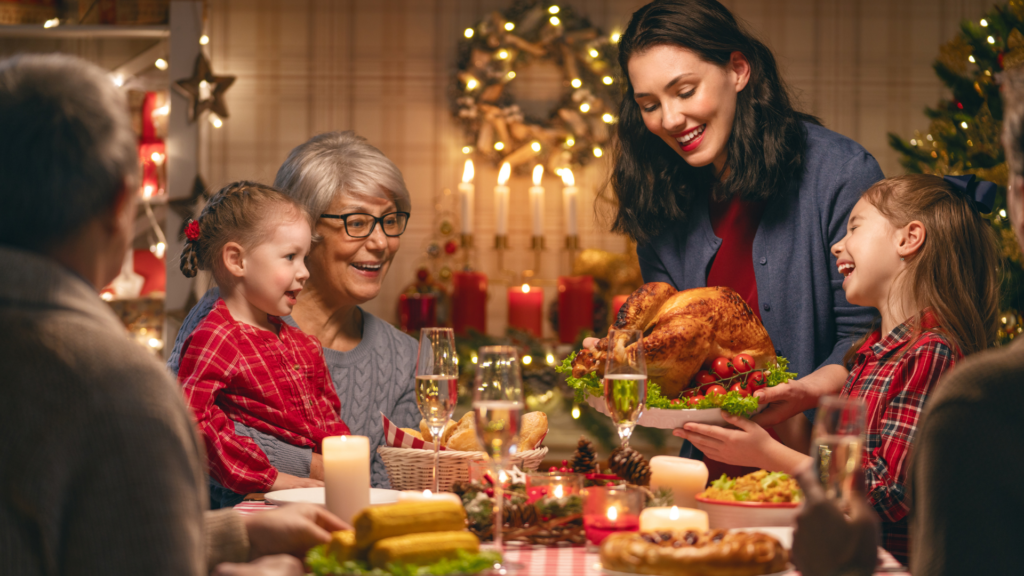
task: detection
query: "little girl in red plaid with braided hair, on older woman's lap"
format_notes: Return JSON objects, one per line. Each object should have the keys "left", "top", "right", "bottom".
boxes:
{"left": 178, "top": 181, "right": 349, "bottom": 500}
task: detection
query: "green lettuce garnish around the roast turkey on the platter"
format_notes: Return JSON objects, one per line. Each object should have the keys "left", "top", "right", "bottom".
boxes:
{"left": 555, "top": 352, "right": 797, "bottom": 416}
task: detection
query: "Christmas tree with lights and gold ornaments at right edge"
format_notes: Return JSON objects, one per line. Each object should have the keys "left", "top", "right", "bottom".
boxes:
{"left": 889, "top": 0, "right": 1024, "bottom": 342}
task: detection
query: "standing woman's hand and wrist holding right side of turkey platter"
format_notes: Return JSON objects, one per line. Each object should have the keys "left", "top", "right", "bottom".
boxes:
{"left": 752, "top": 364, "right": 849, "bottom": 426}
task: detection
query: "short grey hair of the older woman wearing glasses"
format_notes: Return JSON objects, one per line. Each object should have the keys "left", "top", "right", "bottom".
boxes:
{"left": 273, "top": 130, "right": 413, "bottom": 218}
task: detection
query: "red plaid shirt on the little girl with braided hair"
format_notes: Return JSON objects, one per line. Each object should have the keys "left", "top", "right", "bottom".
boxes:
{"left": 178, "top": 300, "right": 349, "bottom": 494}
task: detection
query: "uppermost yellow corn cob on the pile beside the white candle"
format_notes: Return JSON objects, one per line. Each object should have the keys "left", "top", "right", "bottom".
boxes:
{"left": 352, "top": 502, "right": 466, "bottom": 548}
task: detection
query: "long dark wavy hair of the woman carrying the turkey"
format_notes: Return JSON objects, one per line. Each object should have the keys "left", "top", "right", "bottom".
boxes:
{"left": 611, "top": 0, "right": 820, "bottom": 243}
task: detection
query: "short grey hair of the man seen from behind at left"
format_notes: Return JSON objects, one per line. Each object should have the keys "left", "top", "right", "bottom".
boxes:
{"left": 0, "top": 54, "right": 138, "bottom": 251}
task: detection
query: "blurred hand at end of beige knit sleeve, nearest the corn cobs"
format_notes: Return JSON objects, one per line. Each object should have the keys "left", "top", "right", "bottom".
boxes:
{"left": 242, "top": 504, "right": 352, "bottom": 559}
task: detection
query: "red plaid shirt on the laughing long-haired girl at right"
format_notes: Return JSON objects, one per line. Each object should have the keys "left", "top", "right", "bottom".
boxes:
{"left": 841, "top": 313, "right": 963, "bottom": 564}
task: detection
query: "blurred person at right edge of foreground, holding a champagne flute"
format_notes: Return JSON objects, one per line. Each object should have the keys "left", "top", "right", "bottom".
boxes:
{"left": 793, "top": 70, "right": 1024, "bottom": 576}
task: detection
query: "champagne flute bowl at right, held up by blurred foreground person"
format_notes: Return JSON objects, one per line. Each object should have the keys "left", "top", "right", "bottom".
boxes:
{"left": 811, "top": 396, "right": 867, "bottom": 506}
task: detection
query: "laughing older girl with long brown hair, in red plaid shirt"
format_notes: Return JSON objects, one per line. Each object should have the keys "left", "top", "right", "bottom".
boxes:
{"left": 677, "top": 175, "right": 998, "bottom": 563}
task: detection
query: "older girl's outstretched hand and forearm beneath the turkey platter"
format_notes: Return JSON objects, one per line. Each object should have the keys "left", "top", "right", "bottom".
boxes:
{"left": 672, "top": 410, "right": 808, "bottom": 471}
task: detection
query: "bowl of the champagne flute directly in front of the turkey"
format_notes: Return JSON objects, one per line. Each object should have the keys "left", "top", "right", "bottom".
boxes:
{"left": 604, "top": 329, "right": 647, "bottom": 448}
